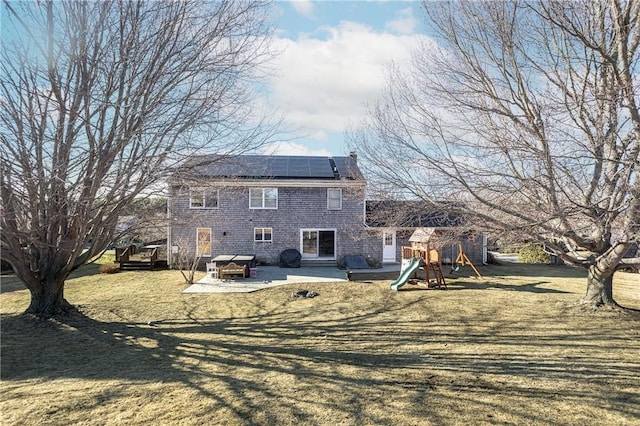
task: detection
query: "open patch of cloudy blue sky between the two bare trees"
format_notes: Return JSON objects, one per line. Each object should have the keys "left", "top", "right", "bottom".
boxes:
{"left": 265, "top": 0, "right": 424, "bottom": 155}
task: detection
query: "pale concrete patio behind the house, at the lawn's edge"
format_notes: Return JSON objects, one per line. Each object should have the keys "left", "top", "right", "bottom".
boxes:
{"left": 183, "top": 264, "right": 400, "bottom": 293}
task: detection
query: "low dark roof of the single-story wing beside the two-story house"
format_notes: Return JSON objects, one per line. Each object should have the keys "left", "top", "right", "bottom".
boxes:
{"left": 366, "top": 200, "right": 462, "bottom": 228}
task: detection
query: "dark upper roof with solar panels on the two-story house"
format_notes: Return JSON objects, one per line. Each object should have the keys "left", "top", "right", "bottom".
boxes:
{"left": 182, "top": 155, "right": 363, "bottom": 180}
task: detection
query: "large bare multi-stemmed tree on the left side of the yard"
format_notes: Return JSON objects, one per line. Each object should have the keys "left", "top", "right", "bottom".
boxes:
{"left": 0, "top": 0, "right": 273, "bottom": 315}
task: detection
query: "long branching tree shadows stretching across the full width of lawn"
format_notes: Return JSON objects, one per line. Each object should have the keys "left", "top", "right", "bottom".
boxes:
{"left": 1, "top": 302, "right": 640, "bottom": 424}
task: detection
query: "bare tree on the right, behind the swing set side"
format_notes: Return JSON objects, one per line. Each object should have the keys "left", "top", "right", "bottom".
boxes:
{"left": 350, "top": 0, "right": 640, "bottom": 306}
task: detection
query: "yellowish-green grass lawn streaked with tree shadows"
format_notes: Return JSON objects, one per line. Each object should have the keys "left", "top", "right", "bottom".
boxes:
{"left": 0, "top": 265, "right": 640, "bottom": 426}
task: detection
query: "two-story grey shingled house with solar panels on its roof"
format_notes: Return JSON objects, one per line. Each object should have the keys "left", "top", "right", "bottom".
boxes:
{"left": 168, "top": 154, "right": 365, "bottom": 264}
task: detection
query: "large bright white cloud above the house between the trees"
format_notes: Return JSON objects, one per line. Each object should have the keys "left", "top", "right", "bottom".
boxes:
{"left": 271, "top": 22, "right": 430, "bottom": 146}
